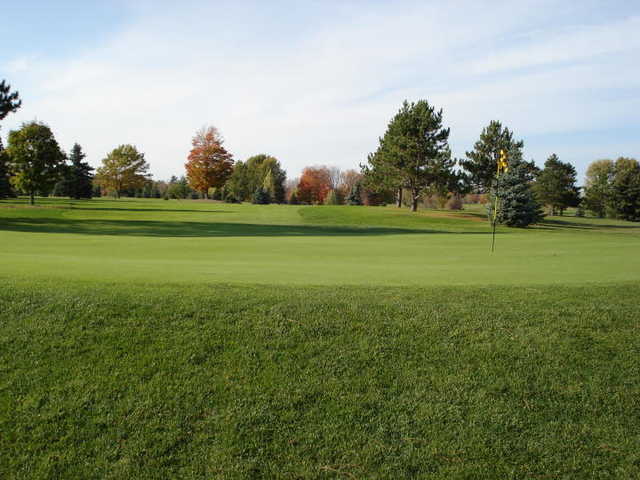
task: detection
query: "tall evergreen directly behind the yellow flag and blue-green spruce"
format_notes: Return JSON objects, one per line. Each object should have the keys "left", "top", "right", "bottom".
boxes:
{"left": 461, "top": 120, "right": 524, "bottom": 193}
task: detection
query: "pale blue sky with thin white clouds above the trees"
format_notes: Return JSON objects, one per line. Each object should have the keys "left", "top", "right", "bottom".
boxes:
{"left": 0, "top": 0, "right": 640, "bottom": 184}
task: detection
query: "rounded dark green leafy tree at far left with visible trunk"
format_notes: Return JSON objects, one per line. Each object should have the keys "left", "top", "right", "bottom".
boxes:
{"left": 7, "top": 122, "right": 65, "bottom": 205}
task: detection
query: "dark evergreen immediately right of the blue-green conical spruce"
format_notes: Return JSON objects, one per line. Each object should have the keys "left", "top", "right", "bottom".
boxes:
{"left": 535, "top": 153, "right": 580, "bottom": 215}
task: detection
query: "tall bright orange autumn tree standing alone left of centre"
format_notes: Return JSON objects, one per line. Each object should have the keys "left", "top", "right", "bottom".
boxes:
{"left": 184, "top": 127, "right": 233, "bottom": 198}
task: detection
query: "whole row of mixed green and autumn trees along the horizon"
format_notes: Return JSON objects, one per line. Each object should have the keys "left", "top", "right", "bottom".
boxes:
{"left": 0, "top": 80, "right": 640, "bottom": 227}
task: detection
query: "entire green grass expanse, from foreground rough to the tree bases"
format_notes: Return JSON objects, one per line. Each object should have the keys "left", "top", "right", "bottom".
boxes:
{"left": 0, "top": 199, "right": 640, "bottom": 479}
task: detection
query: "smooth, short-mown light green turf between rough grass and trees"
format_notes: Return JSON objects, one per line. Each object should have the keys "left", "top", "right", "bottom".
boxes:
{"left": 0, "top": 199, "right": 640, "bottom": 286}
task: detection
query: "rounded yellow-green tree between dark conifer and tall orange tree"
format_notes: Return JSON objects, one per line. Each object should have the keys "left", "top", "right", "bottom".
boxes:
{"left": 96, "top": 145, "right": 150, "bottom": 198}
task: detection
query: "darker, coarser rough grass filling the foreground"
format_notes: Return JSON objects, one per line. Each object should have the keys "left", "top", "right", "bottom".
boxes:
{"left": 0, "top": 280, "right": 640, "bottom": 479}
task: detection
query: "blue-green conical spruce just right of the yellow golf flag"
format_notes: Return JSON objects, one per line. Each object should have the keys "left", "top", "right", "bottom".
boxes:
{"left": 488, "top": 156, "right": 544, "bottom": 227}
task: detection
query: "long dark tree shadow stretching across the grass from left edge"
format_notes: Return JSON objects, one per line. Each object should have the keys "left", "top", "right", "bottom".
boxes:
{"left": 0, "top": 217, "right": 489, "bottom": 237}
